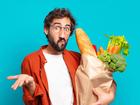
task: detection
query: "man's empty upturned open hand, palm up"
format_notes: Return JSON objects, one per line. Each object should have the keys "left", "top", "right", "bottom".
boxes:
{"left": 7, "top": 74, "right": 36, "bottom": 95}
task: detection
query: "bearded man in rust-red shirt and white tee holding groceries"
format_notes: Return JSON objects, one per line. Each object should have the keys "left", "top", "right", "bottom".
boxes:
{"left": 8, "top": 8, "right": 115, "bottom": 105}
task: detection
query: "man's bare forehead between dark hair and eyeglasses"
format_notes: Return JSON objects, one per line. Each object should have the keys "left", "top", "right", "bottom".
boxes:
{"left": 52, "top": 17, "right": 71, "bottom": 26}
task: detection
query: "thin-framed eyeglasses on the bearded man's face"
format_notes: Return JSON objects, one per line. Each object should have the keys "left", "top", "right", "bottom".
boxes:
{"left": 50, "top": 25, "right": 71, "bottom": 34}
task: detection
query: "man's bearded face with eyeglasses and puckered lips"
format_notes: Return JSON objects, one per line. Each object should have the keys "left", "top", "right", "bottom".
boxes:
{"left": 46, "top": 17, "right": 71, "bottom": 52}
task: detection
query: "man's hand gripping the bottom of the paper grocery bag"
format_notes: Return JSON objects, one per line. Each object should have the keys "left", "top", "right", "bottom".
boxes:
{"left": 93, "top": 87, "right": 115, "bottom": 105}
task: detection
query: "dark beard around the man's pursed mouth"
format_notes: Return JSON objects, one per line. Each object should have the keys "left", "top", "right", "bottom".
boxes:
{"left": 46, "top": 35, "right": 67, "bottom": 52}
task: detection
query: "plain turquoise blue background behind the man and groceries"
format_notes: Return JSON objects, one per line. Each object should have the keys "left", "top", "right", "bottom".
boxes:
{"left": 0, "top": 0, "right": 140, "bottom": 105}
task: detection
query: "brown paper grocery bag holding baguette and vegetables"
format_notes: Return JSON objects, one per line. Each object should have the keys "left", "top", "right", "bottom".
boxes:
{"left": 75, "top": 54, "right": 113, "bottom": 105}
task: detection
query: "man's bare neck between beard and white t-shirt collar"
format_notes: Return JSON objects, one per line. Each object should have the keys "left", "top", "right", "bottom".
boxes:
{"left": 44, "top": 44, "right": 63, "bottom": 55}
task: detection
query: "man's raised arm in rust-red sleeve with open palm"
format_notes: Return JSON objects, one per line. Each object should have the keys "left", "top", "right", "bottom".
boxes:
{"left": 8, "top": 57, "right": 43, "bottom": 105}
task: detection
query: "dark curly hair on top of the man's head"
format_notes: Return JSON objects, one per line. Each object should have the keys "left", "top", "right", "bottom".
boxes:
{"left": 44, "top": 8, "right": 76, "bottom": 36}
